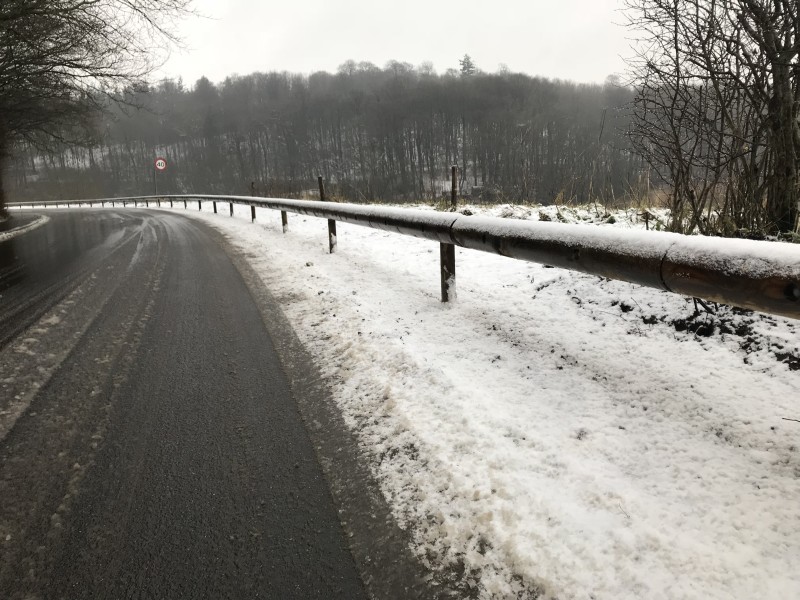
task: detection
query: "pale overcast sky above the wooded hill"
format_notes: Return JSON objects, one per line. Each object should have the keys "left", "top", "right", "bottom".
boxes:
{"left": 158, "top": 0, "right": 628, "bottom": 85}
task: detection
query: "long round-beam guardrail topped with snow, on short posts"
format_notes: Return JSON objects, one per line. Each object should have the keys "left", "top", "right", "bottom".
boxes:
{"left": 8, "top": 195, "right": 800, "bottom": 319}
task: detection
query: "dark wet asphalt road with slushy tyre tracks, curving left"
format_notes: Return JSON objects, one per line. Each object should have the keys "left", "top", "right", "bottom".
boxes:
{"left": 0, "top": 210, "right": 365, "bottom": 600}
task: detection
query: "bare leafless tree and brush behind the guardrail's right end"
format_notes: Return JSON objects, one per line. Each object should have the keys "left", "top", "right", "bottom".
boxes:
{"left": 627, "top": 0, "right": 800, "bottom": 233}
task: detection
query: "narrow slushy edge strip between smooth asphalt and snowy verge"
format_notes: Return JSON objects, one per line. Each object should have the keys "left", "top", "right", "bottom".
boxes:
{"left": 208, "top": 227, "right": 453, "bottom": 600}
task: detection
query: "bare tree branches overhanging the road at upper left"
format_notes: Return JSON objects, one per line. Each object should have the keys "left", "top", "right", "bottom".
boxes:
{"left": 0, "top": 0, "right": 191, "bottom": 213}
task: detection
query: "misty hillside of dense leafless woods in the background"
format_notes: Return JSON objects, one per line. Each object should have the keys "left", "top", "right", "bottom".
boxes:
{"left": 8, "top": 61, "right": 642, "bottom": 203}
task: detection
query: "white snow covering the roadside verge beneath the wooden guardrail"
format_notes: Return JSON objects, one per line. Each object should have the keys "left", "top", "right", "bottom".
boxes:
{"left": 161, "top": 207, "right": 800, "bottom": 600}
